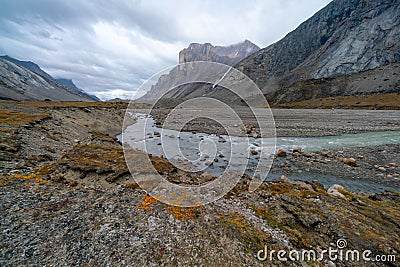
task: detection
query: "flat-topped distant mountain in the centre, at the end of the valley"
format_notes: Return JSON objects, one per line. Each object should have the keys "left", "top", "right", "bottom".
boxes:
{"left": 137, "top": 40, "right": 260, "bottom": 103}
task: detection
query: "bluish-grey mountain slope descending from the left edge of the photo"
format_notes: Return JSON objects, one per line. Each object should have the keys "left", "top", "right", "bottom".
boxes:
{"left": 0, "top": 56, "right": 99, "bottom": 101}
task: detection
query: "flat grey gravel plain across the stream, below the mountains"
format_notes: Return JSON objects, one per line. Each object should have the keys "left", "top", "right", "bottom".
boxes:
{"left": 151, "top": 107, "right": 400, "bottom": 137}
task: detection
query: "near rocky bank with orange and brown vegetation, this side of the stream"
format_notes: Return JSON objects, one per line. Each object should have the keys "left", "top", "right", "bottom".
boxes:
{"left": 0, "top": 101, "right": 400, "bottom": 266}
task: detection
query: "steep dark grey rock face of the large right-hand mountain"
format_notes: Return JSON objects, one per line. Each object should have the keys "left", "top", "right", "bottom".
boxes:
{"left": 236, "top": 0, "right": 400, "bottom": 101}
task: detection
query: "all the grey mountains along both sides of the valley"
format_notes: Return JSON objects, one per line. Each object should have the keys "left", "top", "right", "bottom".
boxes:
{"left": 0, "top": 0, "right": 400, "bottom": 106}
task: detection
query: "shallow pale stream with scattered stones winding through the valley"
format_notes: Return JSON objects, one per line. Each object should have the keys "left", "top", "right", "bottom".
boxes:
{"left": 118, "top": 114, "right": 400, "bottom": 192}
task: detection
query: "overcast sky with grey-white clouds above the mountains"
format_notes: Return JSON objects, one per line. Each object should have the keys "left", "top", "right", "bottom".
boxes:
{"left": 0, "top": 0, "right": 330, "bottom": 99}
